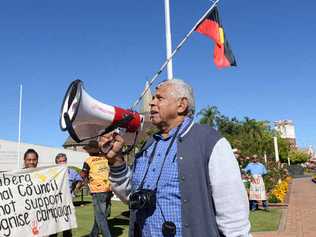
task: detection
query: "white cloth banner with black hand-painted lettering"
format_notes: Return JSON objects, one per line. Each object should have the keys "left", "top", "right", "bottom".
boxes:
{"left": 0, "top": 165, "right": 77, "bottom": 237}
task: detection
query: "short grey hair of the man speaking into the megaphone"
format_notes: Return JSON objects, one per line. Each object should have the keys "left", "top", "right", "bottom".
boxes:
{"left": 156, "top": 79, "right": 195, "bottom": 117}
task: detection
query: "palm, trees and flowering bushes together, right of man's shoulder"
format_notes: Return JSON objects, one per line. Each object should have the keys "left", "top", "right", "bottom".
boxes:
{"left": 198, "top": 106, "right": 290, "bottom": 195}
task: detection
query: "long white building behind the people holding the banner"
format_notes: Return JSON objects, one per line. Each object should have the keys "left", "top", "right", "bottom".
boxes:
{"left": 0, "top": 140, "right": 89, "bottom": 170}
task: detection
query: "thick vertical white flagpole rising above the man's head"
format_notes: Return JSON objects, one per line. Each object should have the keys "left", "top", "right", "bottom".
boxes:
{"left": 165, "top": 0, "right": 173, "bottom": 80}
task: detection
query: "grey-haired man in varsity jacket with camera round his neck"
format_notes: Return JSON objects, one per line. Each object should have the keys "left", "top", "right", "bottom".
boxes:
{"left": 99, "top": 79, "right": 251, "bottom": 237}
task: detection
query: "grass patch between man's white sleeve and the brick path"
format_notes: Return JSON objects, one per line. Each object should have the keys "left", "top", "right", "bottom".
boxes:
{"left": 250, "top": 208, "right": 282, "bottom": 232}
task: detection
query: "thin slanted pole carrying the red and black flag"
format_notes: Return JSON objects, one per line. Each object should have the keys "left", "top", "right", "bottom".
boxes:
{"left": 131, "top": 0, "right": 219, "bottom": 110}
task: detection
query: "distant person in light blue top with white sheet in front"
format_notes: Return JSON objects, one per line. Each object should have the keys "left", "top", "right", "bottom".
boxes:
{"left": 244, "top": 155, "right": 269, "bottom": 211}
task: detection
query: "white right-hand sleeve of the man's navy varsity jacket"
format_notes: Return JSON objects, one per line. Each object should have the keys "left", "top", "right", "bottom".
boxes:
{"left": 208, "top": 138, "right": 251, "bottom": 237}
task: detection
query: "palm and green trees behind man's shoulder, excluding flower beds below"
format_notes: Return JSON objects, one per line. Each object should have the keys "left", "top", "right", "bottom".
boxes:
{"left": 198, "top": 106, "right": 289, "bottom": 163}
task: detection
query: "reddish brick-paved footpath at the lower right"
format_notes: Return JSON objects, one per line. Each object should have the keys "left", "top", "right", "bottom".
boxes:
{"left": 253, "top": 178, "right": 316, "bottom": 237}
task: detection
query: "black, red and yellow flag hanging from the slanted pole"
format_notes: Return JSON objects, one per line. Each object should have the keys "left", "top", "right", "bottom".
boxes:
{"left": 195, "top": 6, "right": 237, "bottom": 68}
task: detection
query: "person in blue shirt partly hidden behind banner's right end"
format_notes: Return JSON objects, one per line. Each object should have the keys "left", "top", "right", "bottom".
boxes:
{"left": 50, "top": 153, "right": 83, "bottom": 237}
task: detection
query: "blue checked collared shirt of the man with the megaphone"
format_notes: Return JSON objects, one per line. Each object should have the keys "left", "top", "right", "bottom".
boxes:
{"left": 132, "top": 118, "right": 192, "bottom": 237}
